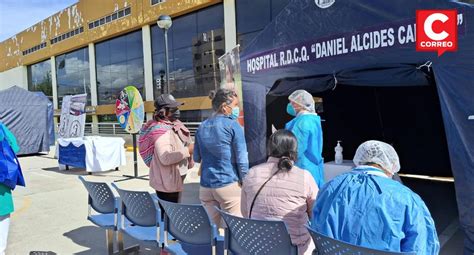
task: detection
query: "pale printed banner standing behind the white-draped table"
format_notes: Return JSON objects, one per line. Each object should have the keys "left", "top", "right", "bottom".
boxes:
{"left": 58, "top": 94, "right": 87, "bottom": 138}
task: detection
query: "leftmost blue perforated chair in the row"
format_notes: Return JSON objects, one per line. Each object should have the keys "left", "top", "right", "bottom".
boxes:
{"left": 79, "top": 176, "right": 121, "bottom": 254}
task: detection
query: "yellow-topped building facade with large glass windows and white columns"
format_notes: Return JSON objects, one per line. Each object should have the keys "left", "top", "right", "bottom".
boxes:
{"left": 0, "top": 0, "right": 290, "bottom": 133}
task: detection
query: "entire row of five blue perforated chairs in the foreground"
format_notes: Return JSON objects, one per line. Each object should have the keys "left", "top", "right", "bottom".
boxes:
{"left": 79, "top": 176, "right": 412, "bottom": 255}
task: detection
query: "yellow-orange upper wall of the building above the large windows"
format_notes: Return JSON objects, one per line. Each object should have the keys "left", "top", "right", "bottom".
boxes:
{"left": 0, "top": 0, "right": 222, "bottom": 72}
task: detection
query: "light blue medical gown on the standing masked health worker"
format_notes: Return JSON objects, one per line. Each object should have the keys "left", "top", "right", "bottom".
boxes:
{"left": 285, "top": 113, "right": 324, "bottom": 187}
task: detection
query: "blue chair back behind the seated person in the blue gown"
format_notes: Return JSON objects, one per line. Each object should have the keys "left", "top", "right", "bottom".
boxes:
{"left": 306, "top": 226, "right": 415, "bottom": 255}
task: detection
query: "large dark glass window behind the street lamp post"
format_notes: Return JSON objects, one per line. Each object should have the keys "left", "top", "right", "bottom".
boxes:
{"left": 151, "top": 4, "right": 225, "bottom": 98}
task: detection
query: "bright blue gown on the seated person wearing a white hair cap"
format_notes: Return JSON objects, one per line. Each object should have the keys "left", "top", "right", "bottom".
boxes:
{"left": 311, "top": 167, "right": 440, "bottom": 255}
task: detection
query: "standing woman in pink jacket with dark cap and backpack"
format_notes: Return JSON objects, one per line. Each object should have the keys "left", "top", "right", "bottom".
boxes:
{"left": 138, "top": 94, "right": 194, "bottom": 216}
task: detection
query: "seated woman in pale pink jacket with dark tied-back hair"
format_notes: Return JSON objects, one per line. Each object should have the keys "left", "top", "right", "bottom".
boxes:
{"left": 242, "top": 130, "right": 318, "bottom": 254}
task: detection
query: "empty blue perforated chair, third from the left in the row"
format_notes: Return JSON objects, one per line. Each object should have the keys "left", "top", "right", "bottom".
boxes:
{"left": 158, "top": 199, "right": 224, "bottom": 255}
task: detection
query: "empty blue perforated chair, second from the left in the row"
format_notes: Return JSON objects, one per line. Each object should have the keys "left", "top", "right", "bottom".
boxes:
{"left": 112, "top": 183, "right": 163, "bottom": 252}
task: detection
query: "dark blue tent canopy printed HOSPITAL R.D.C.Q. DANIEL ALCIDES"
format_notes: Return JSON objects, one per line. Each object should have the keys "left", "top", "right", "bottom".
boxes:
{"left": 241, "top": 0, "right": 474, "bottom": 251}
